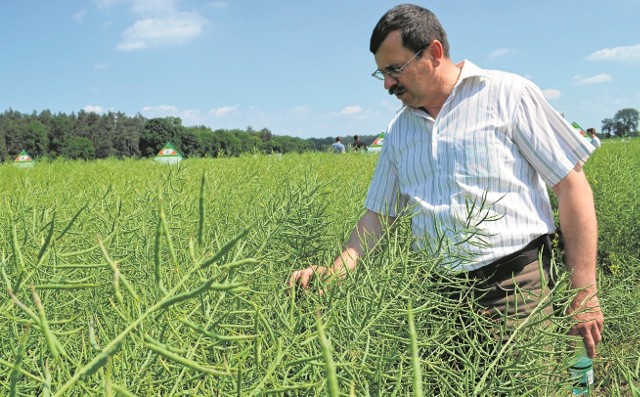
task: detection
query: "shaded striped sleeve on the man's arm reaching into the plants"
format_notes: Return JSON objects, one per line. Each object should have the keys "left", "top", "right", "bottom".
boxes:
{"left": 364, "top": 138, "right": 401, "bottom": 217}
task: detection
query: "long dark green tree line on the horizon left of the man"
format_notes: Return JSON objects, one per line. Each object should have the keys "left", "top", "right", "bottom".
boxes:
{"left": 0, "top": 109, "right": 375, "bottom": 161}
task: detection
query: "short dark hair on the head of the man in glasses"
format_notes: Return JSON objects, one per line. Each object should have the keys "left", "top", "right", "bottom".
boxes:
{"left": 369, "top": 4, "right": 449, "bottom": 58}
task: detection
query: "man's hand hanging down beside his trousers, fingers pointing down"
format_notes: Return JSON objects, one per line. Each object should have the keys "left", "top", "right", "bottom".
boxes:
{"left": 569, "top": 288, "right": 604, "bottom": 358}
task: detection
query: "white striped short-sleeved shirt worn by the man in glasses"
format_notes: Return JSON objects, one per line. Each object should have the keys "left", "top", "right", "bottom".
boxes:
{"left": 365, "top": 61, "right": 593, "bottom": 271}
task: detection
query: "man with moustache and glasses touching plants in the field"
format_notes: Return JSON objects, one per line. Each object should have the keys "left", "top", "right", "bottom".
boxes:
{"left": 289, "top": 5, "right": 603, "bottom": 357}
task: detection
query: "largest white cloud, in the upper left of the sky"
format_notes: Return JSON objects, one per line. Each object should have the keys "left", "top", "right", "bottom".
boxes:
{"left": 116, "top": 12, "right": 207, "bottom": 51}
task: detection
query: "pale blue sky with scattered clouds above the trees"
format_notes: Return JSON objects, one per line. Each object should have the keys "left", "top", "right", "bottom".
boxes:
{"left": 0, "top": 0, "right": 640, "bottom": 138}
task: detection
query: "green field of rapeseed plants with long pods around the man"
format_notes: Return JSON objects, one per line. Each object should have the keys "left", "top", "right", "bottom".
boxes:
{"left": 0, "top": 140, "right": 640, "bottom": 396}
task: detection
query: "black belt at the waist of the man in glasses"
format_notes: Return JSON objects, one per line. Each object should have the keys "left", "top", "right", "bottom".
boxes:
{"left": 467, "top": 234, "right": 551, "bottom": 284}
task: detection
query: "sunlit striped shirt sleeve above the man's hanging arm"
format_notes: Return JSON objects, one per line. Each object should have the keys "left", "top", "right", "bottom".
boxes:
{"left": 513, "top": 81, "right": 594, "bottom": 186}
